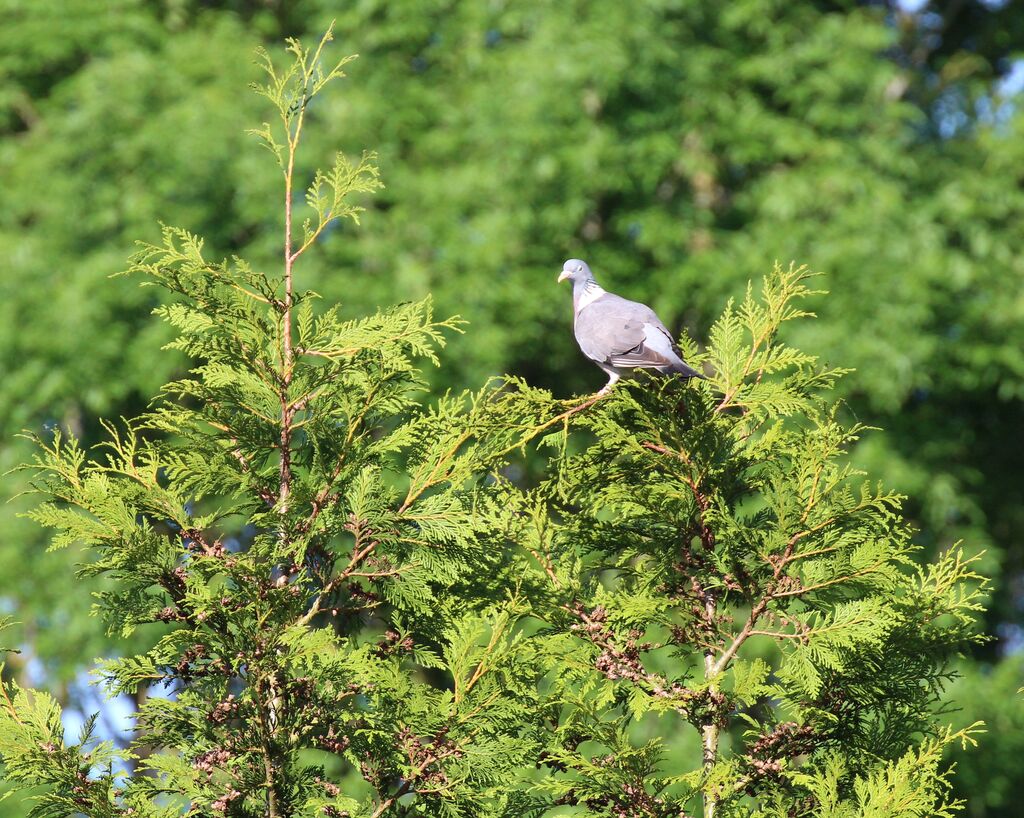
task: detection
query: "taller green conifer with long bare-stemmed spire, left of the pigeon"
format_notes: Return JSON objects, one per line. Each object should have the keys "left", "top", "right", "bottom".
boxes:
{"left": 0, "top": 33, "right": 537, "bottom": 818}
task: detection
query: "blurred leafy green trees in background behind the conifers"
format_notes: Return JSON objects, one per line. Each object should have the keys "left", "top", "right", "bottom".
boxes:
{"left": 0, "top": 0, "right": 1024, "bottom": 818}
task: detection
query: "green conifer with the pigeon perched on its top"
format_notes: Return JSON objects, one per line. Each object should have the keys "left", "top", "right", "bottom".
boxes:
{"left": 506, "top": 268, "right": 984, "bottom": 818}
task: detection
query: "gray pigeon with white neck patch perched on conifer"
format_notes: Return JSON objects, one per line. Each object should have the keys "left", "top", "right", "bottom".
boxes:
{"left": 558, "top": 258, "right": 703, "bottom": 395}
